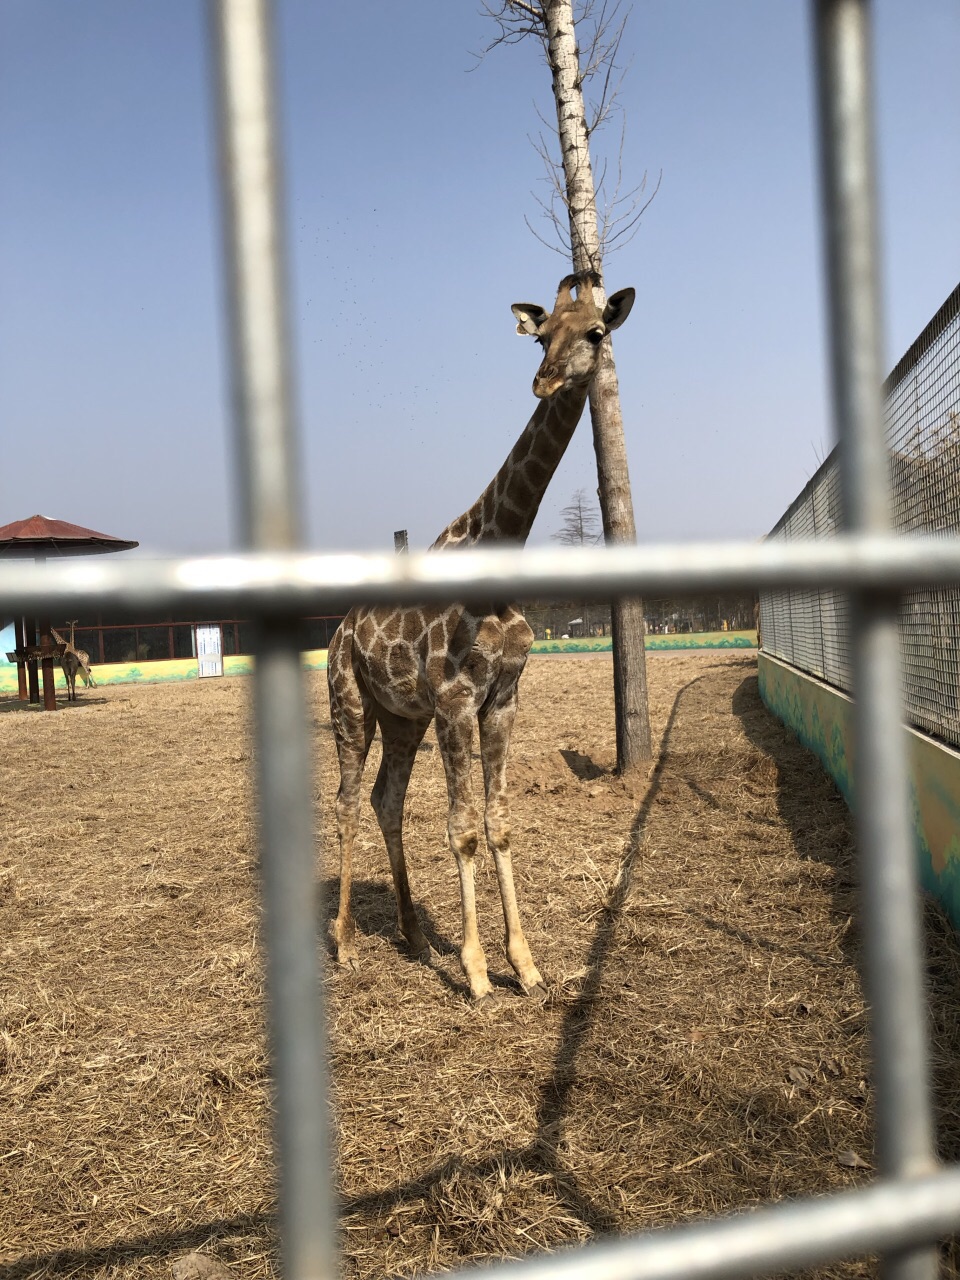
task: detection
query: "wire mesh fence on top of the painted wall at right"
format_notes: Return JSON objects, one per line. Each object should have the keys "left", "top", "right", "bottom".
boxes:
{"left": 760, "top": 285, "right": 960, "bottom": 746}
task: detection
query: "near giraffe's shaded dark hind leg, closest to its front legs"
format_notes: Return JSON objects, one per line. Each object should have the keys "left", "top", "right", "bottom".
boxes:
{"left": 370, "top": 708, "right": 431, "bottom": 961}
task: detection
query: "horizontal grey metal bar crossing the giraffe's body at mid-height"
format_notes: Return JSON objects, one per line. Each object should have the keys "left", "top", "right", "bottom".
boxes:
{"left": 0, "top": 535, "right": 960, "bottom": 617}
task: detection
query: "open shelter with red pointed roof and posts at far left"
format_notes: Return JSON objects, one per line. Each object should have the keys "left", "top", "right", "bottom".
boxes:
{"left": 0, "top": 516, "right": 140, "bottom": 712}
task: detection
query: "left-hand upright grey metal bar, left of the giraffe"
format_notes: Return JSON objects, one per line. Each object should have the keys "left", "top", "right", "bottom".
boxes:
{"left": 210, "top": 0, "right": 337, "bottom": 1280}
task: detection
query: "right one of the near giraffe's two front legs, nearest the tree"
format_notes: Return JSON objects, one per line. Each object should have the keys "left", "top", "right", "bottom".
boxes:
{"left": 480, "top": 689, "right": 547, "bottom": 995}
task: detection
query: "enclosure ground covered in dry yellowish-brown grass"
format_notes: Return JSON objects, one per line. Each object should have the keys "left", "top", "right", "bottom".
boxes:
{"left": 0, "top": 653, "right": 960, "bottom": 1280}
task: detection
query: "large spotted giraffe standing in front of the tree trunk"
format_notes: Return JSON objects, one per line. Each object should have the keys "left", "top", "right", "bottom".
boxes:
{"left": 328, "top": 271, "right": 635, "bottom": 1001}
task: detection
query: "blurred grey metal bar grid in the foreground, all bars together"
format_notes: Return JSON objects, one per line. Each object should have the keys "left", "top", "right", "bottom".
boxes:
{"left": 0, "top": 0, "right": 960, "bottom": 1280}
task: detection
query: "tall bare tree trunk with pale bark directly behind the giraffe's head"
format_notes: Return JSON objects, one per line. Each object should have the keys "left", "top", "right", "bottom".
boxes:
{"left": 543, "top": 0, "right": 652, "bottom": 773}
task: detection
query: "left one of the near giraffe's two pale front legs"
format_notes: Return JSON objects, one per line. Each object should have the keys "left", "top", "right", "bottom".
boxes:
{"left": 436, "top": 699, "right": 493, "bottom": 1001}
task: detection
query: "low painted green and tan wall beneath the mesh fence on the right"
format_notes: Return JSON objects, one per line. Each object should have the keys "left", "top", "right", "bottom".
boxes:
{"left": 758, "top": 653, "right": 960, "bottom": 929}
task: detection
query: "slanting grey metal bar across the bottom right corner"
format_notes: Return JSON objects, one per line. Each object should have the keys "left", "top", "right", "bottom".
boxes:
{"left": 456, "top": 1169, "right": 960, "bottom": 1280}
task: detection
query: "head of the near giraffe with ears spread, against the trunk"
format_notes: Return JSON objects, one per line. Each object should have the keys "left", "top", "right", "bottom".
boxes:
{"left": 511, "top": 271, "right": 636, "bottom": 399}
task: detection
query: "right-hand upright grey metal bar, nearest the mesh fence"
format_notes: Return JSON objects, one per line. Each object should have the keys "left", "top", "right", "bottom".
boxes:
{"left": 814, "top": 0, "right": 937, "bottom": 1280}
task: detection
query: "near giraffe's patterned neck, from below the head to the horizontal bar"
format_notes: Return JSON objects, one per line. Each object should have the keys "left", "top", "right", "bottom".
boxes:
{"left": 431, "top": 387, "right": 588, "bottom": 550}
